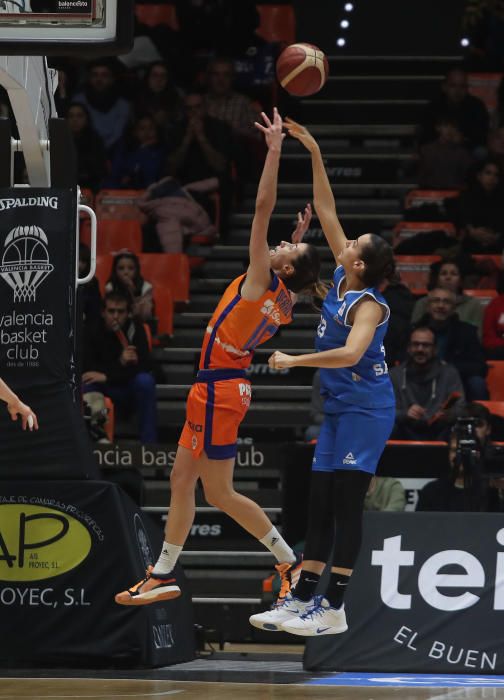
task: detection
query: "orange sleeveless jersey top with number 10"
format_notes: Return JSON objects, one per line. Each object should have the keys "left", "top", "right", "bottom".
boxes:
{"left": 199, "top": 275, "right": 292, "bottom": 369}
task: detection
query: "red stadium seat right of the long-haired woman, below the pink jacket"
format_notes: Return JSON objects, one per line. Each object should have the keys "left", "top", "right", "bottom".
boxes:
{"left": 138, "top": 253, "right": 190, "bottom": 302}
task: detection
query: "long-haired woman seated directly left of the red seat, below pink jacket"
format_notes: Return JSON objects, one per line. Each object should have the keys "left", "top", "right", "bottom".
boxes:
{"left": 105, "top": 251, "right": 154, "bottom": 322}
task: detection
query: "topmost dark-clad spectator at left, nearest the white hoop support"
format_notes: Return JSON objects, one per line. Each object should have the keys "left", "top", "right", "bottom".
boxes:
{"left": 74, "top": 59, "right": 131, "bottom": 154}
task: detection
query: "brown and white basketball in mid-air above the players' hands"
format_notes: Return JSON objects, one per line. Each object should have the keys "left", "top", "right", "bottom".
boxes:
{"left": 276, "top": 44, "right": 329, "bottom": 97}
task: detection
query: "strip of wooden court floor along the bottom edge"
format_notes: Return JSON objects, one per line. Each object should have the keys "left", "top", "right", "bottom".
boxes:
{"left": 0, "top": 674, "right": 504, "bottom": 700}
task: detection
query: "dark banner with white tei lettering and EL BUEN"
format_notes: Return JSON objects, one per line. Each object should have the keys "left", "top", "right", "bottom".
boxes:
{"left": 304, "top": 513, "right": 504, "bottom": 674}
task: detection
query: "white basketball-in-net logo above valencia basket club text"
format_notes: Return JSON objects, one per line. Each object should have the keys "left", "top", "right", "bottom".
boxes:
{"left": 0, "top": 226, "right": 54, "bottom": 302}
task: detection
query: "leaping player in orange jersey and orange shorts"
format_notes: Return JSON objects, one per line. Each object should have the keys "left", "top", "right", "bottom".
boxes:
{"left": 115, "top": 109, "right": 320, "bottom": 605}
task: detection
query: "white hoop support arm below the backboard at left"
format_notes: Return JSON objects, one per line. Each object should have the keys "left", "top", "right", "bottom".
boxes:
{"left": 0, "top": 56, "right": 58, "bottom": 187}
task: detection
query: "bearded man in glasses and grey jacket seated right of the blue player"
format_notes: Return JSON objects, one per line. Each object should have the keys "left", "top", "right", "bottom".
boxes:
{"left": 390, "top": 326, "right": 464, "bottom": 440}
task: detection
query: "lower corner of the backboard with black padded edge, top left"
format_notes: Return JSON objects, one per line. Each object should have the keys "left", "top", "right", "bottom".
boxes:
{"left": 0, "top": 0, "right": 134, "bottom": 58}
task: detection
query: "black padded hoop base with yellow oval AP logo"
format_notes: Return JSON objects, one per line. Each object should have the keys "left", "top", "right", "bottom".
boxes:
{"left": 0, "top": 481, "right": 194, "bottom": 666}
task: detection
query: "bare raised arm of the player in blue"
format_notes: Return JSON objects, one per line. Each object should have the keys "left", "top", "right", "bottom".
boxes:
{"left": 285, "top": 119, "right": 347, "bottom": 259}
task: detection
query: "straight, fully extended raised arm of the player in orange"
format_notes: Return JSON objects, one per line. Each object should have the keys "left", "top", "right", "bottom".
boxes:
{"left": 242, "top": 107, "right": 285, "bottom": 300}
